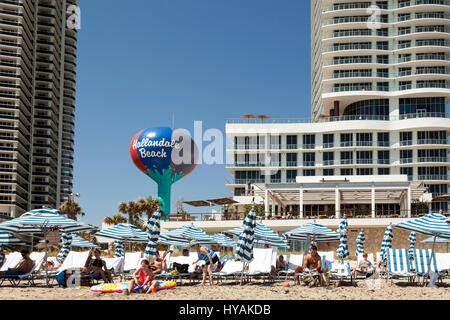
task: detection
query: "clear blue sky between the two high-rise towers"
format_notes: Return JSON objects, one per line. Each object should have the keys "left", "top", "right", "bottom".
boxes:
{"left": 73, "top": 0, "right": 310, "bottom": 225}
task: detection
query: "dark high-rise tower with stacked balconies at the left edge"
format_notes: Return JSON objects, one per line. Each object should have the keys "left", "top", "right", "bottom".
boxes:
{"left": 0, "top": 0, "right": 78, "bottom": 217}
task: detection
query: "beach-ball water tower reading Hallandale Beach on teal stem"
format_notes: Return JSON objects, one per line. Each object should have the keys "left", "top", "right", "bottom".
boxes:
{"left": 130, "top": 127, "right": 198, "bottom": 218}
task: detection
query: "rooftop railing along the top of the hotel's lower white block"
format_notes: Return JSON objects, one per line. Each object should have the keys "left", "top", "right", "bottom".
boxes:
{"left": 226, "top": 112, "right": 450, "bottom": 124}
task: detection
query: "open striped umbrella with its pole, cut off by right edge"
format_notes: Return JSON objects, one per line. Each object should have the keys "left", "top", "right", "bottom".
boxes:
{"left": 394, "top": 213, "right": 450, "bottom": 282}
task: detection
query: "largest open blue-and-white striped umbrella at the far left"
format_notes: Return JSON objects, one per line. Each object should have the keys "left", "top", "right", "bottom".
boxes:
{"left": 0, "top": 209, "right": 95, "bottom": 233}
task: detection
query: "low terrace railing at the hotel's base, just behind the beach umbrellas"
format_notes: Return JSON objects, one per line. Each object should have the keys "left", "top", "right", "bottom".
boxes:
{"left": 169, "top": 210, "right": 450, "bottom": 222}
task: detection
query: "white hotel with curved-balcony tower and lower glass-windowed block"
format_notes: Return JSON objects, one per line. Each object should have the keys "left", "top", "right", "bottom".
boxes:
{"left": 226, "top": 0, "right": 450, "bottom": 219}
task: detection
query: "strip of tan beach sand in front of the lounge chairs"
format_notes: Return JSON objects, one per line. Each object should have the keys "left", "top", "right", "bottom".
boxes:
{"left": 0, "top": 279, "right": 450, "bottom": 300}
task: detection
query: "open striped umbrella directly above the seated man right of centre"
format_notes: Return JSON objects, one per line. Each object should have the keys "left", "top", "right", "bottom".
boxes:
{"left": 284, "top": 222, "right": 340, "bottom": 242}
